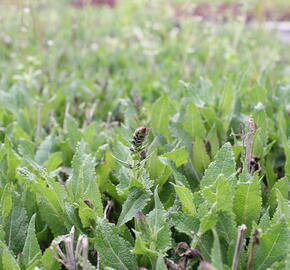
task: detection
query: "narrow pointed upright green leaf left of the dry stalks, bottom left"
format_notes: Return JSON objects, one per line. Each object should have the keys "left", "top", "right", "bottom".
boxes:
{"left": 22, "top": 214, "right": 41, "bottom": 268}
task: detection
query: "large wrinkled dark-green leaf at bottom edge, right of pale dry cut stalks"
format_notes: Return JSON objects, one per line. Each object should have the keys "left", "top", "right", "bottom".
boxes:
{"left": 95, "top": 218, "right": 137, "bottom": 270}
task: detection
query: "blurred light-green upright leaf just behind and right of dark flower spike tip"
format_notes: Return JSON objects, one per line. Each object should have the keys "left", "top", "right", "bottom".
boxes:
{"left": 151, "top": 96, "right": 170, "bottom": 138}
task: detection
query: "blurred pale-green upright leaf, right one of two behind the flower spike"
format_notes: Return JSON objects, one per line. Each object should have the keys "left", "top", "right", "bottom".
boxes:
{"left": 183, "top": 102, "right": 206, "bottom": 138}
